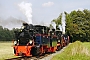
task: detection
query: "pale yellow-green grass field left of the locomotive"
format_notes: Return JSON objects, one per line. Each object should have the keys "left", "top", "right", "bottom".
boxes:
{"left": 0, "top": 41, "right": 16, "bottom": 60}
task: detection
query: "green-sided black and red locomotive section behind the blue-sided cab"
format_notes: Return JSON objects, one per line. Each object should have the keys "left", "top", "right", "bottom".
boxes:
{"left": 44, "top": 29, "right": 57, "bottom": 52}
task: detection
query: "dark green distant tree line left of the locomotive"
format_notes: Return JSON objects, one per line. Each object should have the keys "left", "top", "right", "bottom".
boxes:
{"left": 0, "top": 26, "right": 19, "bottom": 41}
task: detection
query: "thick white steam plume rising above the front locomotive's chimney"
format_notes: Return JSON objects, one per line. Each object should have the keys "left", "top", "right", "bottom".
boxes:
{"left": 18, "top": 1, "right": 32, "bottom": 24}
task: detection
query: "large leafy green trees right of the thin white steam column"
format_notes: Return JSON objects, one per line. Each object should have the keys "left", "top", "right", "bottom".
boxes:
{"left": 66, "top": 9, "right": 90, "bottom": 41}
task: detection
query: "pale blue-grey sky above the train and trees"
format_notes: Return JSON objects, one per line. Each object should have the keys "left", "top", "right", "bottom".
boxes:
{"left": 0, "top": 0, "right": 90, "bottom": 28}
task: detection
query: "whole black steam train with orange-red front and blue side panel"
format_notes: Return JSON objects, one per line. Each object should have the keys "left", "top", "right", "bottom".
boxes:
{"left": 13, "top": 23, "right": 69, "bottom": 56}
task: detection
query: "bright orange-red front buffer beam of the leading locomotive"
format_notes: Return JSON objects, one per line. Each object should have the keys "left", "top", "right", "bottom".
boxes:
{"left": 14, "top": 46, "right": 32, "bottom": 56}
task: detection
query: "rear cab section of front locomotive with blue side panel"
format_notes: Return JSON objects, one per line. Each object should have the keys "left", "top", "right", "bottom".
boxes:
{"left": 32, "top": 25, "right": 49, "bottom": 55}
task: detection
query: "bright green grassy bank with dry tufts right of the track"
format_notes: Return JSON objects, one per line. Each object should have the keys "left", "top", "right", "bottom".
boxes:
{"left": 51, "top": 41, "right": 90, "bottom": 60}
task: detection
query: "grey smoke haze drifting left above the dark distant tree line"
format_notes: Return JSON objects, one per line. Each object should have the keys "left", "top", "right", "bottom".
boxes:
{"left": 0, "top": 16, "right": 25, "bottom": 30}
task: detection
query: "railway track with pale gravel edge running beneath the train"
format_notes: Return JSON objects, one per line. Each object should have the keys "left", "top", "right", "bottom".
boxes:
{"left": 5, "top": 49, "right": 63, "bottom": 60}
